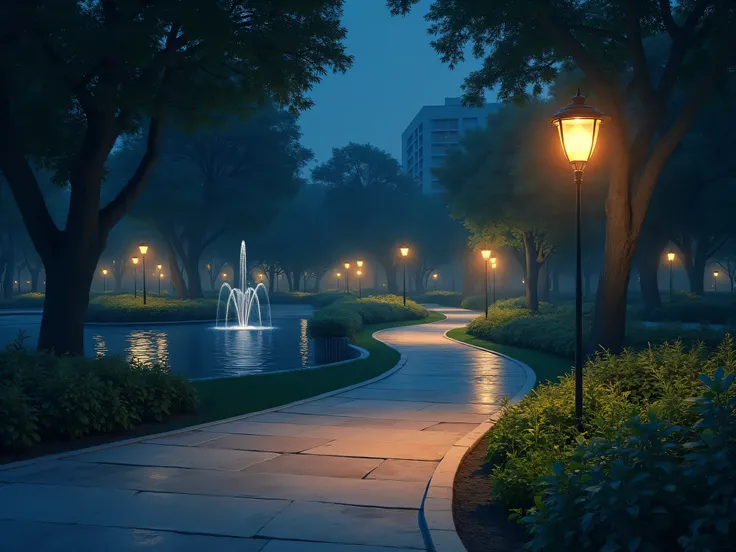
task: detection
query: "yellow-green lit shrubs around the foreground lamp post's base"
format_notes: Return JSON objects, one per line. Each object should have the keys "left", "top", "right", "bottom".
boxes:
{"left": 487, "top": 336, "right": 736, "bottom": 509}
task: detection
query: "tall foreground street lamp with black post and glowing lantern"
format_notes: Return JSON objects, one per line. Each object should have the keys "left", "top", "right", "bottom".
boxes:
{"left": 550, "top": 90, "right": 609, "bottom": 431}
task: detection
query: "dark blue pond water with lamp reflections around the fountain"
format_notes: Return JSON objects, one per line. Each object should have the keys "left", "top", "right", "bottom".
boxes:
{"left": 0, "top": 305, "right": 314, "bottom": 378}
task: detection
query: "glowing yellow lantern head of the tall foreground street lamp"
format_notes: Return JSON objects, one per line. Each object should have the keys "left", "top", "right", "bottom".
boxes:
{"left": 550, "top": 90, "right": 609, "bottom": 170}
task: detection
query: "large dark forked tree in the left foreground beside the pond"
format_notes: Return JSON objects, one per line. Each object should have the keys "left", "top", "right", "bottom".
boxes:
{"left": 0, "top": 0, "right": 351, "bottom": 355}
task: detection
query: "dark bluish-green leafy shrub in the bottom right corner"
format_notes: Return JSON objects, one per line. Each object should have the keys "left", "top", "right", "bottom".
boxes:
{"left": 523, "top": 368, "right": 736, "bottom": 552}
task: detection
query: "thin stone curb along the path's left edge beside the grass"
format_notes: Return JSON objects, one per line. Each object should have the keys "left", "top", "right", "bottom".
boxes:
{"left": 0, "top": 319, "right": 426, "bottom": 472}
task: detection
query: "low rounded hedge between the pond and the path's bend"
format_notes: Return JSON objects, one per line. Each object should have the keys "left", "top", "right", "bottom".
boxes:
{"left": 309, "top": 295, "right": 429, "bottom": 340}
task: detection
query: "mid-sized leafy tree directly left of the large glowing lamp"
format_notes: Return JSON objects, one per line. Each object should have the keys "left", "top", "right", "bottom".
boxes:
{"left": 436, "top": 104, "right": 595, "bottom": 310}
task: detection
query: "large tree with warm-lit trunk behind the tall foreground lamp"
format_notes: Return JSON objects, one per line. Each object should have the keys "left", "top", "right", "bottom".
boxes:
{"left": 388, "top": 0, "right": 736, "bottom": 350}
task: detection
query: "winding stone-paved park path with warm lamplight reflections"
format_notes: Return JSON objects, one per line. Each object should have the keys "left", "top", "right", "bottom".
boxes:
{"left": 0, "top": 309, "right": 529, "bottom": 552}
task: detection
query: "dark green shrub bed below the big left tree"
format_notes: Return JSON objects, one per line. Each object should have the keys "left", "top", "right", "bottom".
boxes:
{"left": 0, "top": 348, "right": 195, "bottom": 449}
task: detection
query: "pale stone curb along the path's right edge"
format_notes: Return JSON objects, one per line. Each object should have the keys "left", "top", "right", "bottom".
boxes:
{"left": 419, "top": 330, "right": 537, "bottom": 552}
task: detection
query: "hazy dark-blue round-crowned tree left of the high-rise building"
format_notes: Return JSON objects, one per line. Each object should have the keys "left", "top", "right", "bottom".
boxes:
{"left": 312, "top": 143, "right": 419, "bottom": 293}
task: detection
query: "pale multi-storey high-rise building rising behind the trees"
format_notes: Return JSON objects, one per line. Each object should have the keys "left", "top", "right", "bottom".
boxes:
{"left": 401, "top": 98, "right": 499, "bottom": 194}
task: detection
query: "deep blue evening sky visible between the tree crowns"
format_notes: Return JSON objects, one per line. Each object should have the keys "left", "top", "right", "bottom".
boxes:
{"left": 300, "top": 0, "right": 495, "bottom": 168}
